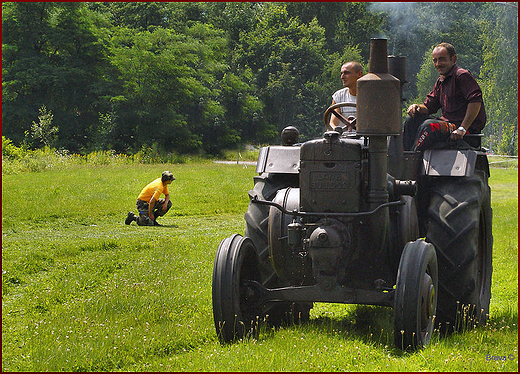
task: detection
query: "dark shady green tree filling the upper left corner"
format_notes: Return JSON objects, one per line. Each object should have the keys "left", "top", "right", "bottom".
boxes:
{"left": 2, "top": 3, "right": 109, "bottom": 150}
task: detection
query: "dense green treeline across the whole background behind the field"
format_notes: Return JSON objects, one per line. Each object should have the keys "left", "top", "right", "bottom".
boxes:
{"left": 2, "top": 2, "right": 518, "bottom": 154}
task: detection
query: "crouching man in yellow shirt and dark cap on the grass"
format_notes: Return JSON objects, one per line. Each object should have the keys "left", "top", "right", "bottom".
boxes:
{"left": 125, "top": 170, "right": 175, "bottom": 226}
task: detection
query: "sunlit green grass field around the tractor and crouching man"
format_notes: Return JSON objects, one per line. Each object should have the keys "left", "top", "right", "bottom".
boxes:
{"left": 2, "top": 162, "right": 518, "bottom": 372}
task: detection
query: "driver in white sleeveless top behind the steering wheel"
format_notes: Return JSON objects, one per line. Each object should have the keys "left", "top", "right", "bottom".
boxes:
{"left": 329, "top": 61, "right": 363, "bottom": 131}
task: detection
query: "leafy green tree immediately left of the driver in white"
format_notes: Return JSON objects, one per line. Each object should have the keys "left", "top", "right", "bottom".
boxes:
{"left": 237, "top": 4, "right": 326, "bottom": 136}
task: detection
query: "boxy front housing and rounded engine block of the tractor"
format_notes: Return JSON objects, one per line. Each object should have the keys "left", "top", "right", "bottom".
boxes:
{"left": 268, "top": 131, "right": 368, "bottom": 287}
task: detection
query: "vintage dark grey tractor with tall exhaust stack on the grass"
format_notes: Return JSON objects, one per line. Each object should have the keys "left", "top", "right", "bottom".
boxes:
{"left": 212, "top": 39, "right": 492, "bottom": 349}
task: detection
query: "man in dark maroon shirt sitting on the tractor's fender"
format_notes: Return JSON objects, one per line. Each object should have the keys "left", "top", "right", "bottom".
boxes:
{"left": 403, "top": 43, "right": 486, "bottom": 151}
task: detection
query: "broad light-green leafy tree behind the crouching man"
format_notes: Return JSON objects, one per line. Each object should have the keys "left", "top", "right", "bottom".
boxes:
{"left": 106, "top": 23, "right": 268, "bottom": 153}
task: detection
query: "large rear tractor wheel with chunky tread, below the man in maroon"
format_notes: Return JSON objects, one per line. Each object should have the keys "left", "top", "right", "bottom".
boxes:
{"left": 426, "top": 171, "right": 493, "bottom": 332}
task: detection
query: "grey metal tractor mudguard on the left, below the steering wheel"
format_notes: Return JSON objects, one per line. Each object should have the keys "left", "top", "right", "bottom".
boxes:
{"left": 256, "top": 146, "right": 300, "bottom": 174}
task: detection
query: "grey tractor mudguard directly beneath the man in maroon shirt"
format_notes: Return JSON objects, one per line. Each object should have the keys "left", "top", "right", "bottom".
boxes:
{"left": 422, "top": 149, "right": 477, "bottom": 177}
